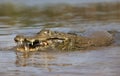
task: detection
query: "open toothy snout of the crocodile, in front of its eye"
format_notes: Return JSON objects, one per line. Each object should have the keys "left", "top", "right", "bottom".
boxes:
{"left": 14, "top": 35, "right": 47, "bottom": 52}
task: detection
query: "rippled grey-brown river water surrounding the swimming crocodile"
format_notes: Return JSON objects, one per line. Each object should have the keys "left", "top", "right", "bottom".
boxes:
{"left": 0, "top": 22, "right": 120, "bottom": 76}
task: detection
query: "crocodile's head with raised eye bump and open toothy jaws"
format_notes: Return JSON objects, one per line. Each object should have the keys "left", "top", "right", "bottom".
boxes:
{"left": 14, "top": 30, "right": 65, "bottom": 52}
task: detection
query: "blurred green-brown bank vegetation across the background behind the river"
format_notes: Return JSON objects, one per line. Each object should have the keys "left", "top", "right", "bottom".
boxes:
{"left": 0, "top": 2, "right": 120, "bottom": 25}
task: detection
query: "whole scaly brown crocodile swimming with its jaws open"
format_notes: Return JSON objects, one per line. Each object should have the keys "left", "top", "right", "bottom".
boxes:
{"left": 14, "top": 30, "right": 113, "bottom": 52}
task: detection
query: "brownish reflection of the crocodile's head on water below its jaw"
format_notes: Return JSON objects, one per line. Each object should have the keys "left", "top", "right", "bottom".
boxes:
{"left": 16, "top": 52, "right": 72, "bottom": 68}
